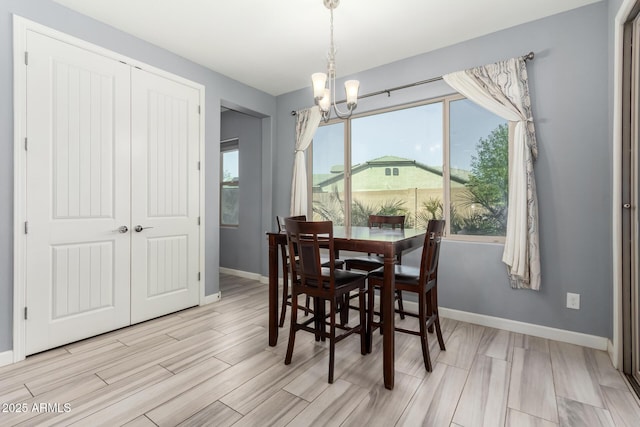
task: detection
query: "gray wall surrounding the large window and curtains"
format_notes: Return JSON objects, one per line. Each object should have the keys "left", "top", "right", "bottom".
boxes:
{"left": 274, "top": 2, "right": 612, "bottom": 337}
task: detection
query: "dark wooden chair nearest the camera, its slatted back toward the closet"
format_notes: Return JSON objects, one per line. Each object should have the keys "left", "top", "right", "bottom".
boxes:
{"left": 284, "top": 219, "right": 367, "bottom": 383}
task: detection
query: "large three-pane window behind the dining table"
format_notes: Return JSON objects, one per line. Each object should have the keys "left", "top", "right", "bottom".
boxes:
{"left": 309, "top": 95, "right": 508, "bottom": 241}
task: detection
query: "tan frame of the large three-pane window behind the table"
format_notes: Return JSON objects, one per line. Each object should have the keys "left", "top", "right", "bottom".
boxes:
{"left": 307, "top": 93, "right": 506, "bottom": 244}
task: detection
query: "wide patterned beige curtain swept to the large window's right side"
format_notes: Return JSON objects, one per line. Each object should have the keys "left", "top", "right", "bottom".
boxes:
{"left": 443, "top": 58, "right": 540, "bottom": 290}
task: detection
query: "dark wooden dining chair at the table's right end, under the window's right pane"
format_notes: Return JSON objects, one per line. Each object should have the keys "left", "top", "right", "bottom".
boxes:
{"left": 368, "top": 220, "right": 445, "bottom": 372}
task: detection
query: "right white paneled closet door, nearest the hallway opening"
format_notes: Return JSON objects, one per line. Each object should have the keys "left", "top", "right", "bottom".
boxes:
{"left": 131, "top": 69, "right": 200, "bottom": 323}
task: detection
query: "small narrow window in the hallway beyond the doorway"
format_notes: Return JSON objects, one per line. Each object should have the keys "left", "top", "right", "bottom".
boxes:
{"left": 220, "top": 139, "right": 240, "bottom": 226}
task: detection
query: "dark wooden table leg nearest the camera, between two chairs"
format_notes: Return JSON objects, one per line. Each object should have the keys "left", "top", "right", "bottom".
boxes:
{"left": 380, "top": 253, "right": 395, "bottom": 390}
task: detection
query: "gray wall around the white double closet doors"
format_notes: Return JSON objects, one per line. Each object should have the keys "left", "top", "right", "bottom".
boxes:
{"left": 0, "top": 0, "right": 276, "bottom": 352}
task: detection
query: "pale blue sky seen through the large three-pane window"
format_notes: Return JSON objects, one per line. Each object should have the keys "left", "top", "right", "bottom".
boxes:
{"left": 313, "top": 99, "right": 505, "bottom": 174}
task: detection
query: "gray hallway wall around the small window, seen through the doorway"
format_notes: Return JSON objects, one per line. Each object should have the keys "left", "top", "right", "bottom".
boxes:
{"left": 220, "top": 111, "right": 265, "bottom": 273}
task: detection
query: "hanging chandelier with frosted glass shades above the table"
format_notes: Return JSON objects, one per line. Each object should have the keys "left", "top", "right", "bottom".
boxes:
{"left": 311, "top": 0, "right": 360, "bottom": 122}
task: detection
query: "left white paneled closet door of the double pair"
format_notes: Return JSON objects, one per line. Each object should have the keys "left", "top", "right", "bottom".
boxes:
{"left": 25, "top": 31, "right": 131, "bottom": 354}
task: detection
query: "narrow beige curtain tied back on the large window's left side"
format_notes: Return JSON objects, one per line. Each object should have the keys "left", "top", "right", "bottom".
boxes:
{"left": 290, "top": 106, "right": 322, "bottom": 216}
